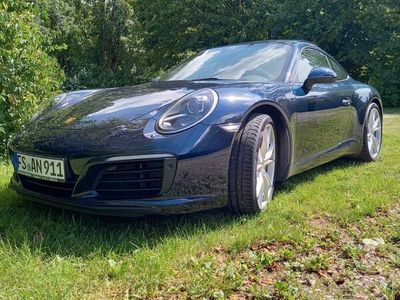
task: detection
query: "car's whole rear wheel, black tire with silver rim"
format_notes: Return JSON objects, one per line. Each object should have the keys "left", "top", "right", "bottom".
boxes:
{"left": 359, "top": 103, "right": 382, "bottom": 162}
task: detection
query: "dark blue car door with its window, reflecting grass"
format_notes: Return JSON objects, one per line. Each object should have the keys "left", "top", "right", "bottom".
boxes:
{"left": 293, "top": 48, "right": 353, "bottom": 164}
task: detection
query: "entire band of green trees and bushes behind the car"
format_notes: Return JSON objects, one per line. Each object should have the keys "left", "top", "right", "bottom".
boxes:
{"left": 0, "top": 0, "right": 400, "bottom": 157}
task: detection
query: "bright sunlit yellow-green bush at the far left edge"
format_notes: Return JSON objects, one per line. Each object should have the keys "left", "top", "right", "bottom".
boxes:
{"left": 0, "top": 0, "right": 64, "bottom": 156}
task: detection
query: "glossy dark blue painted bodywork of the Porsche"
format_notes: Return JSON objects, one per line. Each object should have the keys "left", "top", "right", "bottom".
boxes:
{"left": 10, "top": 41, "right": 382, "bottom": 215}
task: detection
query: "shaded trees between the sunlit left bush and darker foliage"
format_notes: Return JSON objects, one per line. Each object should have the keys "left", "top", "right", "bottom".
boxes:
{"left": 36, "top": 0, "right": 143, "bottom": 90}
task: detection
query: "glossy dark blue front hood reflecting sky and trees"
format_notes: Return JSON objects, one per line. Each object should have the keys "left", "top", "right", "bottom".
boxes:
{"left": 30, "top": 82, "right": 209, "bottom": 130}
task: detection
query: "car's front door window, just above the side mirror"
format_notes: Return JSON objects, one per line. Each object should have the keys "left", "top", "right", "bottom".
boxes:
{"left": 294, "top": 48, "right": 330, "bottom": 82}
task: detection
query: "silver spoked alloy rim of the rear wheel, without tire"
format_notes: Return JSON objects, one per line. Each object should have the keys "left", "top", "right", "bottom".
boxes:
{"left": 367, "top": 108, "right": 382, "bottom": 159}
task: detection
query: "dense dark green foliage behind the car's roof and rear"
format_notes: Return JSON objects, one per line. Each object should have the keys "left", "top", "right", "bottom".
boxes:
{"left": 137, "top": 0, "right": 400, "bottom": 106}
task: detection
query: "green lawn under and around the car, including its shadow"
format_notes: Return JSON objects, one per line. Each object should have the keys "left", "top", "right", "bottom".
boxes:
{"left": 0, "top": 111, "right": 400, "bottom": 299}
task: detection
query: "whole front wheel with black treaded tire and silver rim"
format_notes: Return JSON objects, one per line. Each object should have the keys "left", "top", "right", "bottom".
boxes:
{"left": 229, "top": 114, "right": 278, "bottom": 214}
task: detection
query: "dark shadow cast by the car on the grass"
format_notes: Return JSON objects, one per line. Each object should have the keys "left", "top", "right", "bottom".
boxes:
{"left": 0, "top": 159, "right": 361, "bottom": 257}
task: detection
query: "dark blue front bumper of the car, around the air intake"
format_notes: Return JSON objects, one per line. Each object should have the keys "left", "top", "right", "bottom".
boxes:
{"left": 10, "top": 125, "right": 234, "bottom": 216}
